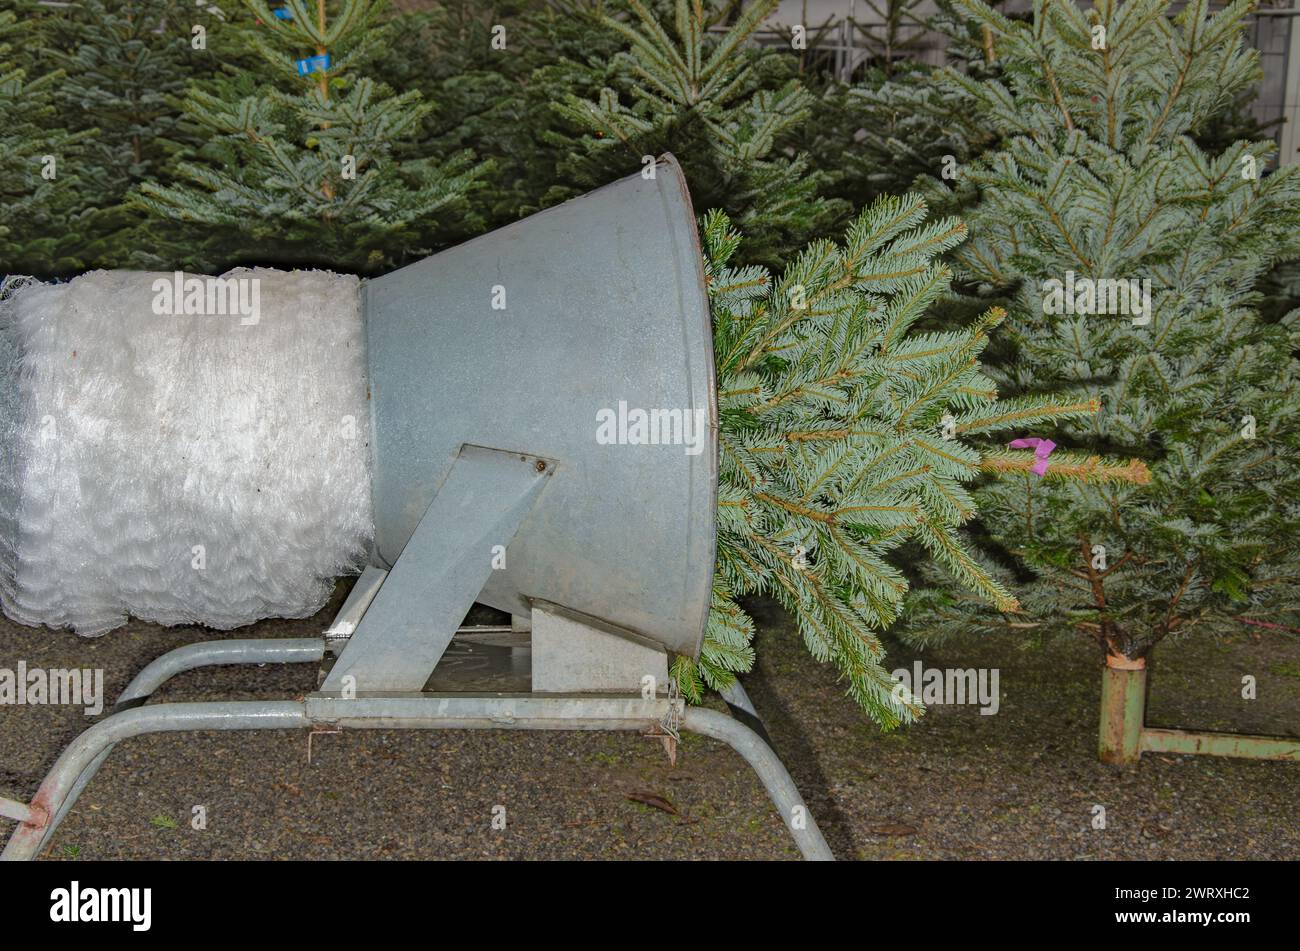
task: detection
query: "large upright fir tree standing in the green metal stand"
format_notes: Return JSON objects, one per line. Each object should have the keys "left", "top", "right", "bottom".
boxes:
{"left": 894, "top": 0, "right": 1300, "bottom": 659}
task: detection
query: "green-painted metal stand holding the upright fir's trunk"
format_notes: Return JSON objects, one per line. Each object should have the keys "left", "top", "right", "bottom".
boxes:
{"left": 1099, "top": 655, "right": 1300, "bottom": 765}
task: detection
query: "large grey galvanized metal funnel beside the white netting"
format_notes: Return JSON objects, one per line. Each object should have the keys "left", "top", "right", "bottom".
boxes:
{"left": 361, "top": 156, "right": 718, "bottom": 657}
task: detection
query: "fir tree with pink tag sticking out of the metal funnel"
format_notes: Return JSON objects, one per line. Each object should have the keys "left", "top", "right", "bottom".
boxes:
{"left": 691, "top": 195, "right": 1144, "bottom": 726}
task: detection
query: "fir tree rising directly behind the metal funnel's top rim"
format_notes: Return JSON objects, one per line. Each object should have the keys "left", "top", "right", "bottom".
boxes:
{"left": 555, "top": 0, "right": 848, "bottom": 260}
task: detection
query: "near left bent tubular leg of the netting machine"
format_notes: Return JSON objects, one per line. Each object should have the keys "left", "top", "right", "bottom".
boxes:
{"left": 0, "top": 700, "right": 311, "bottom": 861}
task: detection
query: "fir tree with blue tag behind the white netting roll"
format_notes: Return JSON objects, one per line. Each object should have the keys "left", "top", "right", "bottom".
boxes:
{"left": 139, "top": 0, "right": 481, "bottom": 270}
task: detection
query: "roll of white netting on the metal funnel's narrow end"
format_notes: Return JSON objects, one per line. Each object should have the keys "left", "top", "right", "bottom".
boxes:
{"left": 0, "top": 269, "right": 373, "bottom": 635}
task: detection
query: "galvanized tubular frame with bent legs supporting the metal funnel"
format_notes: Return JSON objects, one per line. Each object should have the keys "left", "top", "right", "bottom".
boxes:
{"left": 0, "top": 638, "right": 835, "bottom": 860}
